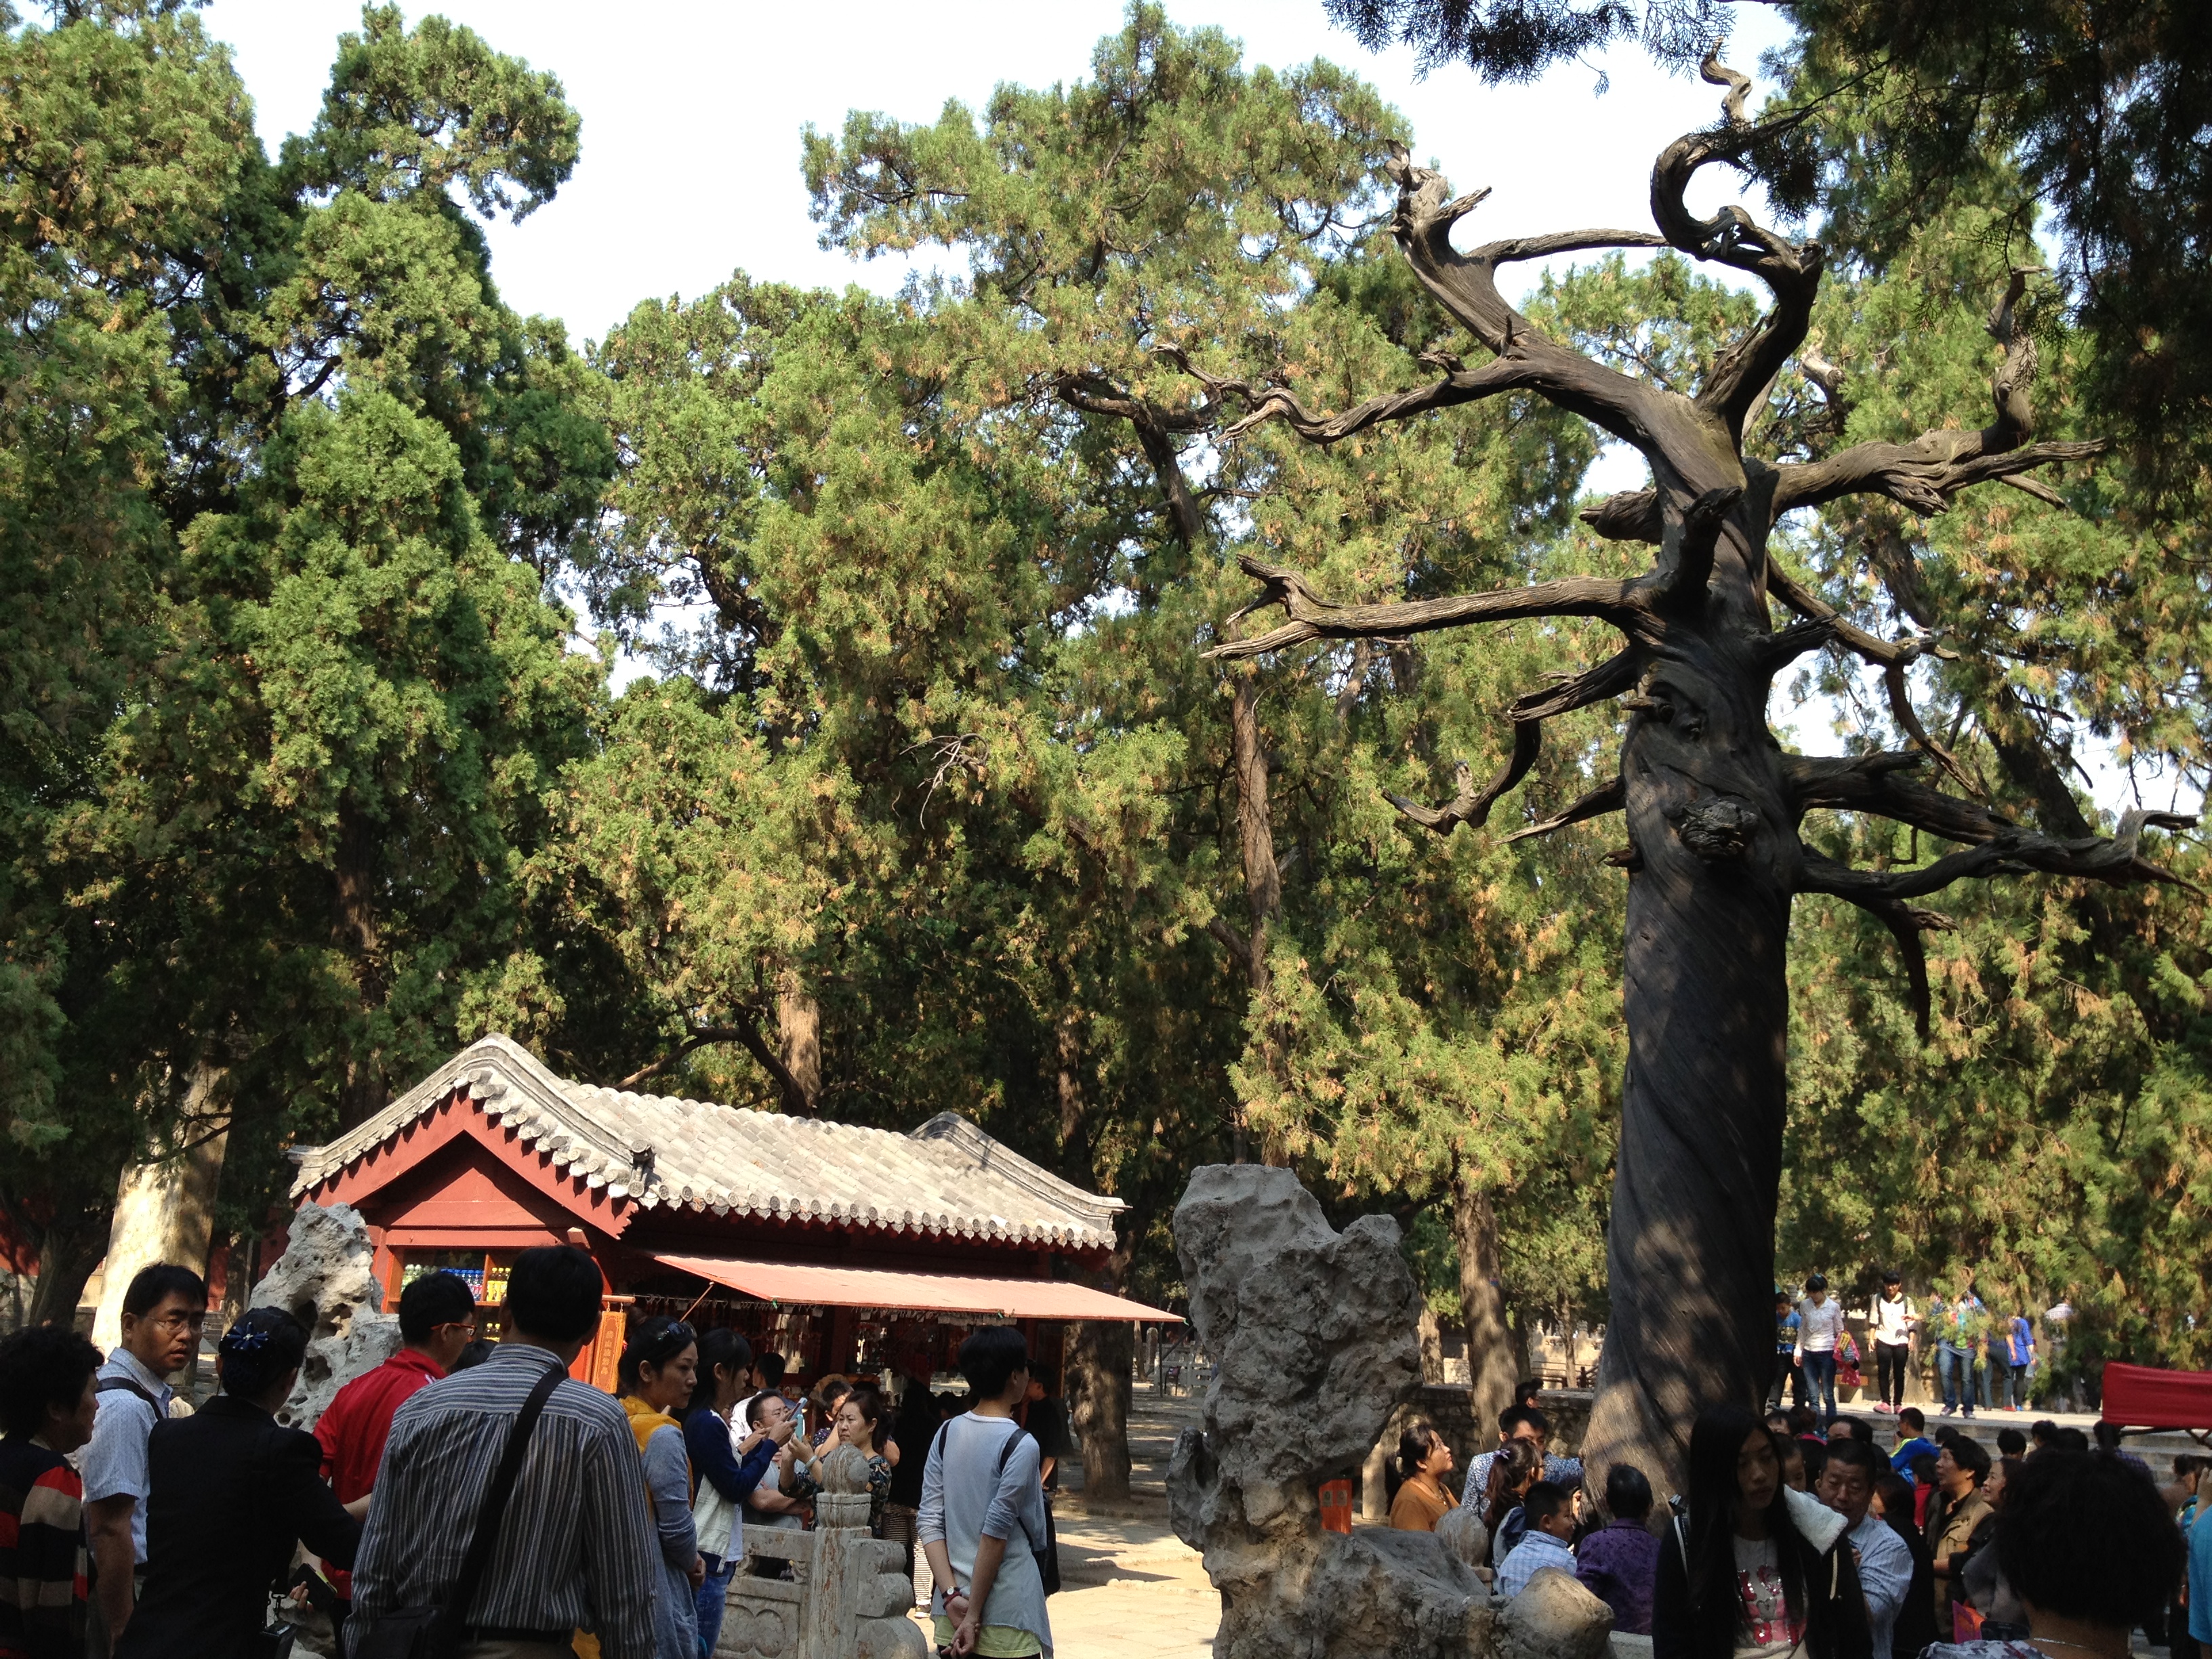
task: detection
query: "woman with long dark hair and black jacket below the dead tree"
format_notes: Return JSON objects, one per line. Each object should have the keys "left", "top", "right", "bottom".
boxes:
{"left": 1652, "top": 1405, "right": 1874, "bottom": 1659}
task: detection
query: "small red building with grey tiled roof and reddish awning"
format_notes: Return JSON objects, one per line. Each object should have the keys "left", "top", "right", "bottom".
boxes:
{"left": 292, "top": 1038, "right": 1174, "bottom": 1387}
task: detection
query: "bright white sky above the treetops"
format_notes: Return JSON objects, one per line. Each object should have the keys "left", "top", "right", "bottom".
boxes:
{"left": 206, "top": 0, "right": 1781, "bottom": 351}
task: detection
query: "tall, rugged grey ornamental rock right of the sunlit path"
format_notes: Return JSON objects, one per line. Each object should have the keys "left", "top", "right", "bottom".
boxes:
{"left": 1168, "top": 1164, "right": 1491, "bottom": 1659}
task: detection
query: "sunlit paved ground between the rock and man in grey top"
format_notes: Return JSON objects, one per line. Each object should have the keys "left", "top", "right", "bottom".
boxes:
{"left": 918, "top": 1385, "right": 1221, "bottom": 1659}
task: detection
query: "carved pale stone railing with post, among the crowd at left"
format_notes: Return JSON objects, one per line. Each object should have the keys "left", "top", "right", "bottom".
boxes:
{"left": 714, "top": 1447, "right": 929, "bottom": 1659}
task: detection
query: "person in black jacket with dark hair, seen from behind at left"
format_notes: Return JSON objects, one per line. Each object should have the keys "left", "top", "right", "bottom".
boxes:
{"left": 115, "top": 1307, "right": 367, "bottom": 1659}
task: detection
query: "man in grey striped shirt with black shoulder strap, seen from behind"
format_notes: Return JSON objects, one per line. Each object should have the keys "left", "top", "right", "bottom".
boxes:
{"left": 347, "top": 1246, "right": 657, "bottom": 1659}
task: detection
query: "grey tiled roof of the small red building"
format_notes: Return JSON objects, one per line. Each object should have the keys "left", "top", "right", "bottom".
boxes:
{"left": 292, "top": 1038, "right": 1126, "bottom": 1250}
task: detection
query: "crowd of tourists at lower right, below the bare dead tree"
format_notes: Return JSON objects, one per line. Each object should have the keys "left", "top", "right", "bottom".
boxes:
{"left": 1391, "top": 1385, "right": 2212, "bottom": 1659}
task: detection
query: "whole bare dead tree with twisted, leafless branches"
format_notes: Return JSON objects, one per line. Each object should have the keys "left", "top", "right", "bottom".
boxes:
{"left": 1174, "top": 58, "right": 2192, "bottom": 1480}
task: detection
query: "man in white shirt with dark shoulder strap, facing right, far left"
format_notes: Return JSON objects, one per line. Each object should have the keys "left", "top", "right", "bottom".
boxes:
{"left": 82, "top": 1263, "right": 208, "bottom": 1659}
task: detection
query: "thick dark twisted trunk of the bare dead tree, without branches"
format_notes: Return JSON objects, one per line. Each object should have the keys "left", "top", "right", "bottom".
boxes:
{"left": 1584, "top": 619, "right": 1801, "bottom": 1489}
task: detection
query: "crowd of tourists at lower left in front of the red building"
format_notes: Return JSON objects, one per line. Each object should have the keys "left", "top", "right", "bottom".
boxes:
{"left": 0, "top": 1246, "right": 1071, "bottom": 1659}
